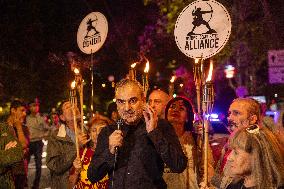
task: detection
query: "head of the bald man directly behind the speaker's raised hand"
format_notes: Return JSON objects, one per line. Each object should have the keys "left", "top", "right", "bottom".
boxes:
{"left": 148, "top": 89, "right": 170, "bottom": 119}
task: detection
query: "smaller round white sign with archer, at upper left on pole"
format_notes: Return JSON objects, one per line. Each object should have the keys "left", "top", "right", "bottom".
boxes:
{"left": 77, "top": 12, "right": 108, "bottom": 54}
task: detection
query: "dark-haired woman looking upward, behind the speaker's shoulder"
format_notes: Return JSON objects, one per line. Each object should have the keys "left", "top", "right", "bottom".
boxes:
{"left": 163, "top": 96, "right": 213, "bottom": 189}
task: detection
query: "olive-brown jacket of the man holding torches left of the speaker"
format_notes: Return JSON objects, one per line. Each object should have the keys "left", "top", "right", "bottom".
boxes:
{"left": 46, "top": 125, "right": 76, "bottom": 189}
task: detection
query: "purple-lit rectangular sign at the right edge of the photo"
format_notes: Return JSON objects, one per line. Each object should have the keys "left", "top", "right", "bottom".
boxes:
{"left": 268, "top": 50, "right": 284, "bottom": 84}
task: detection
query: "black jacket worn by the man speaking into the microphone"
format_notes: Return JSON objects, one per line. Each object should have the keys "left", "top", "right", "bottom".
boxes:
{"left": 88, "top": 120, "right": 187, "bottom": 189}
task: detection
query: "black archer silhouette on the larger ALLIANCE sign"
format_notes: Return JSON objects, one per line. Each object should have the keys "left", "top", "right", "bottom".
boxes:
{"left": 187, "top": 7, "right": 217, "bottom": 36}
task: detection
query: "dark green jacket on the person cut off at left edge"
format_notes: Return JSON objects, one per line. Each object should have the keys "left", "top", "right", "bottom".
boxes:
{"left": 0, "top": 123, "right": 24, "bottom": 189}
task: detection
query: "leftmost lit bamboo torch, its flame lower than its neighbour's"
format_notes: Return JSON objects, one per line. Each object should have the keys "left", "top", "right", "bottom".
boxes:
{"left": 69, "top": 81, "right": 80, "bottom": 157}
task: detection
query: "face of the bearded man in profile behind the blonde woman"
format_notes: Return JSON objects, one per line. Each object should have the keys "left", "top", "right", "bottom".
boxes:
{"left": 228, "top": 101, "right": 250, "bottom": 131}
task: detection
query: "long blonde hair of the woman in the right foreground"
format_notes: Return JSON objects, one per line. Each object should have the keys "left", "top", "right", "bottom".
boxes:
{"left": 229, "top": 125, "right": 284, "bottom": 189}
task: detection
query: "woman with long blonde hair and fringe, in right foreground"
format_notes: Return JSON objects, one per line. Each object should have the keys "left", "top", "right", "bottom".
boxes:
{"left": 224, "top": 125, "right": 284, "bottom": 189}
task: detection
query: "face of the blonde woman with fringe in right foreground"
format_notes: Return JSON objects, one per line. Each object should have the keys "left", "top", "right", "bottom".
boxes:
{"left": 228, "top": 148, "right": 253, "bottom": 176}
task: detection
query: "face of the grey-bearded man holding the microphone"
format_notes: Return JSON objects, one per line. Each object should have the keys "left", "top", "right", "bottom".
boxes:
{"left": 115, "top": 84, "right": 145, "bottom": 125}
